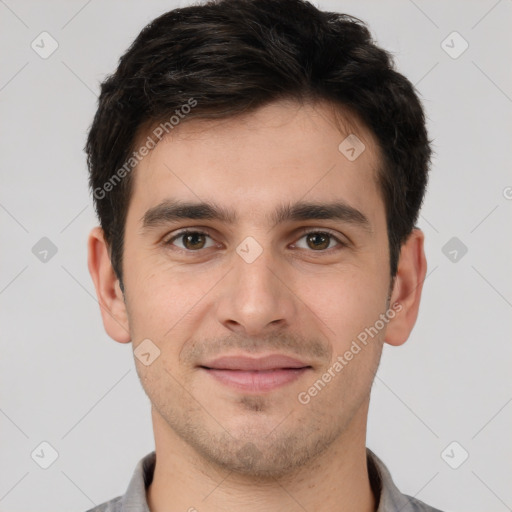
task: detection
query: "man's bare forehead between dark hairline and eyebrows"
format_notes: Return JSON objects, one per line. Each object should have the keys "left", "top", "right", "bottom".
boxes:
{"left": 129, "top": 102, "right": 384, "bottom": 227}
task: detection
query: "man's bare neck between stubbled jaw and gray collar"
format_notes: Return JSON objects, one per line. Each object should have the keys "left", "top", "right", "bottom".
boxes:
{"left": 146, "top": 408, "right": 377, "bottom": 512}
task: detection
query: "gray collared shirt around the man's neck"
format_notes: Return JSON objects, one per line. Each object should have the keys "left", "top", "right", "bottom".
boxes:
{"left": 87, "top": 448, "right": 441, "bottom": 512}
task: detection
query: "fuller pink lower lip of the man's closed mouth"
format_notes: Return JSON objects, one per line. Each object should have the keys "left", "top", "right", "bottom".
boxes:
{"left": 204, "top": 368, "right": 310, "bottom": 392}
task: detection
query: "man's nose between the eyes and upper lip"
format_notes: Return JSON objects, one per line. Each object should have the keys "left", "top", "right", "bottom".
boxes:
{"left": 216, "top": 243, "right": 298, "bottom": 336}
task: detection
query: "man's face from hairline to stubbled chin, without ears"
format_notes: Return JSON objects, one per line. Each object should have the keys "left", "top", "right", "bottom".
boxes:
{"left": 123, "top": 103, "right": 390, "bottom": 476}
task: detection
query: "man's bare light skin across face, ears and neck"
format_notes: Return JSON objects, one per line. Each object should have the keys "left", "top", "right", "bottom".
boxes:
{"left": 88, "top": 102, "right": 426, "bottom": 512}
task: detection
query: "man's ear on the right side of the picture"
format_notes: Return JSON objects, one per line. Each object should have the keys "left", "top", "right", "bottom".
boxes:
{"left": 385, "top": 228, "right": 427, "bottom": 346}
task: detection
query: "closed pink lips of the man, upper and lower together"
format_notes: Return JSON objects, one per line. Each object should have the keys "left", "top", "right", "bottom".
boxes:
{"left": 200, "top": 354, "right": 312, "bottom": 393}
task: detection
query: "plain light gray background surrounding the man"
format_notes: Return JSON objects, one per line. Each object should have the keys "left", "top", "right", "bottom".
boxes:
{"left": 0, "top": 0, "right": 512, "bottom": 512}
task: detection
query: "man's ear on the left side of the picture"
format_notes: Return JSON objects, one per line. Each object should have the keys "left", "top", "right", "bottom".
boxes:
{"left": 87, "top": 227, "right": 131, "bottom": 343}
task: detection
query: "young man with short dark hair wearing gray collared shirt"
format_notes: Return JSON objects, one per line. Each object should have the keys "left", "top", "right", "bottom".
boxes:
{"left": 86, "top": 0, "right": 442, "bottom": 512}
